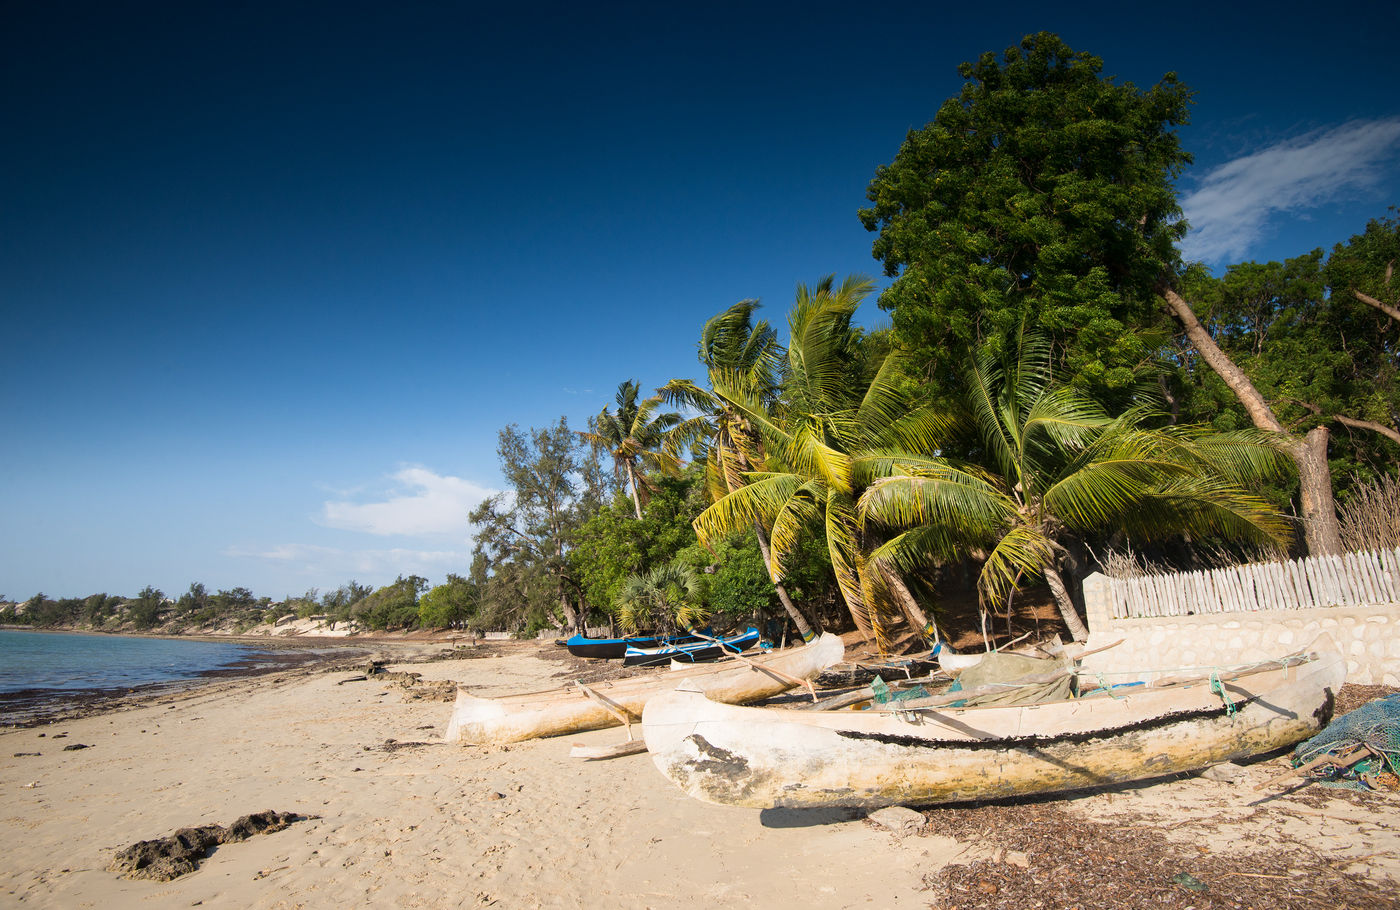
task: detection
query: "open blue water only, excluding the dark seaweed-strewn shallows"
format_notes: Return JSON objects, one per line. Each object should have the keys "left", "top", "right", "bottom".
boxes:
{"left": 0, "top": 629, "right": 281, "bottom": 696}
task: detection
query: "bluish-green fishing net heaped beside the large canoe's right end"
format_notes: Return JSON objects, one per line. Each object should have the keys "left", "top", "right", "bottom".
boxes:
{"left": 1294, "top": 694, "right": 1400, "bottom": 790}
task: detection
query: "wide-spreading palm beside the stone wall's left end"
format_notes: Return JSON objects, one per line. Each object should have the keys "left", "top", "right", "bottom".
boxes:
{"left": 860, "top": 331, "right": 1288, "bottom": 641}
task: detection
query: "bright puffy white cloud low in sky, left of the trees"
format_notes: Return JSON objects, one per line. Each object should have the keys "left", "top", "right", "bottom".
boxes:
{"left": 321, "top": 468, "right": 497, "bottom": 538}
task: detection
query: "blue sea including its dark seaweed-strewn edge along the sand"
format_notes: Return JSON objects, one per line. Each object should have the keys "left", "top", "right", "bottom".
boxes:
{"left": 0, "top": 629, "right": 333, "bottom": 724}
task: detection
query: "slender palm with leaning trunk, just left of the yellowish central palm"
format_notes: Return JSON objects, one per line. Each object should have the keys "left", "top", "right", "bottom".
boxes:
{"left": 657, "top": 300, "right": 816, "bottom": 641}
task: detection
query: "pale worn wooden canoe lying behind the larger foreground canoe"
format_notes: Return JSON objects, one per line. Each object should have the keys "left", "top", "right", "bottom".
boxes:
{"left": 447, "top": 634, "right": 846, "bottom": 743}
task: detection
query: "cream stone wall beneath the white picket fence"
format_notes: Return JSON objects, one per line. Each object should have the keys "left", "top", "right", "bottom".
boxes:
{"left": 1084, "top": 573, "right": 1400, "bottom": 686}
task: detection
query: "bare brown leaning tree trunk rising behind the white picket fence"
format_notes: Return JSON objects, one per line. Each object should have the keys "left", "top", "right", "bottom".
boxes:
{"left": 1163, "top": 288, "right": 1341, "bottom": 556}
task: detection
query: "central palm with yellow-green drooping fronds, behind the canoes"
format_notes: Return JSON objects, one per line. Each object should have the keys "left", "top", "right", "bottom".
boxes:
{"left": 694, "top": 276, "right": 942, "bottom": 648}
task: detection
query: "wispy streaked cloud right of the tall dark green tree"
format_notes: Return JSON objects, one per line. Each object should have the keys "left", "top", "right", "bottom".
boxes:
{"left": 1182, "top": 118, "right": 1400, "bottom": 262}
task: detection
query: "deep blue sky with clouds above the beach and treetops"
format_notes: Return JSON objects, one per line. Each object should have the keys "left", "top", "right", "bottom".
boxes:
{"left": 0, "top": 0, "right": 1400, "bottom": 599}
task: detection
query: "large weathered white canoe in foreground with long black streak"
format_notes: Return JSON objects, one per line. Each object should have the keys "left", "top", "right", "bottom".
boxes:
{"left": 643, "top": 651, "right": 1347, "bottom": 809}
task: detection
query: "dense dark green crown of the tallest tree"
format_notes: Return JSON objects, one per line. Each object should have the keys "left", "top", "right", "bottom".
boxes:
{"left": 860, "top": 32, "right": 1190, "bottom": 392}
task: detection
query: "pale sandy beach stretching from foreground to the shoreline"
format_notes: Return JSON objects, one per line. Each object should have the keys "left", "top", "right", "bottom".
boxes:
{"left": 0, "top": 643, "right": 1400, "bottom": 909}
